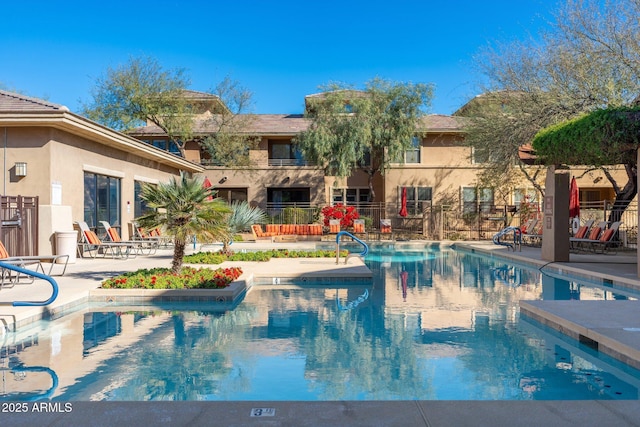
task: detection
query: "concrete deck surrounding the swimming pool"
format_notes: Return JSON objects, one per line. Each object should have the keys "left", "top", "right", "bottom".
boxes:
{"left": 0, "top": 242, "right": 640, "bottom": 426}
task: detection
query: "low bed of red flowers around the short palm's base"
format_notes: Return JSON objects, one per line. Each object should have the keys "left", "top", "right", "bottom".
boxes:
{"left": 102, "top": 267, "right": 242, "bottom": 289}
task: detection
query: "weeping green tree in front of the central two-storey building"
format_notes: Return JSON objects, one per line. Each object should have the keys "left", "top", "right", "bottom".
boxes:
{"left": 296, "top": 78, "right": 433, "bottom": 201}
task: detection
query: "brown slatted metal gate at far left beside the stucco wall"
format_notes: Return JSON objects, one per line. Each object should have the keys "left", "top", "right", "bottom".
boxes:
{"left": 0, "top": 196, "right": 38, "bottom": 256}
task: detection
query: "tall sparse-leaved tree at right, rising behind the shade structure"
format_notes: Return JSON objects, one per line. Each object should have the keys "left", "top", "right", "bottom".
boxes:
{"left": 461, "top": 0, "right": 640, "bottom": 199}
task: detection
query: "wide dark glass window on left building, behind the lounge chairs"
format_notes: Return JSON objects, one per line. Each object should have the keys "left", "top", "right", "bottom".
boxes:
{"left": 84, "top": 172, "right": 120, "bottom": 232}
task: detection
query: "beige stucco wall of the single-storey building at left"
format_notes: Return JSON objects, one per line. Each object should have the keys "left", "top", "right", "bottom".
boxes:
{"left": 0, "top": 127, "right": 188, "bottom": 254}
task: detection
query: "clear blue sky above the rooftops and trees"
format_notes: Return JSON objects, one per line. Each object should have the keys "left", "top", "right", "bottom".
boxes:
{"left": 0, "top": 0, "right": 557, "bottom": 114}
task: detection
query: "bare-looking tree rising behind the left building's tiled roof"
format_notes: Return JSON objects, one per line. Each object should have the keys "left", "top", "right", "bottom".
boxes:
{"left": 82, "top": 57, "right": 193, "bottom": 155}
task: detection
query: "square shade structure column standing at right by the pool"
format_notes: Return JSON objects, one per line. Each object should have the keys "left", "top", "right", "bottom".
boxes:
{"left": 541, "top": 166, "right": 569, "bottom": 262}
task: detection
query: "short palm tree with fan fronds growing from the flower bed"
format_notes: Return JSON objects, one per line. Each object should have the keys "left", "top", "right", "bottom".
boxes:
{"left": 136, "top": 172, "right": 231, "bottom": 274}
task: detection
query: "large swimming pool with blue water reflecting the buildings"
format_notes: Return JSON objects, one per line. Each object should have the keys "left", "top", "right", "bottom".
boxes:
{"left": 0, "top": 247, "right": 640, "bottom": 401}
